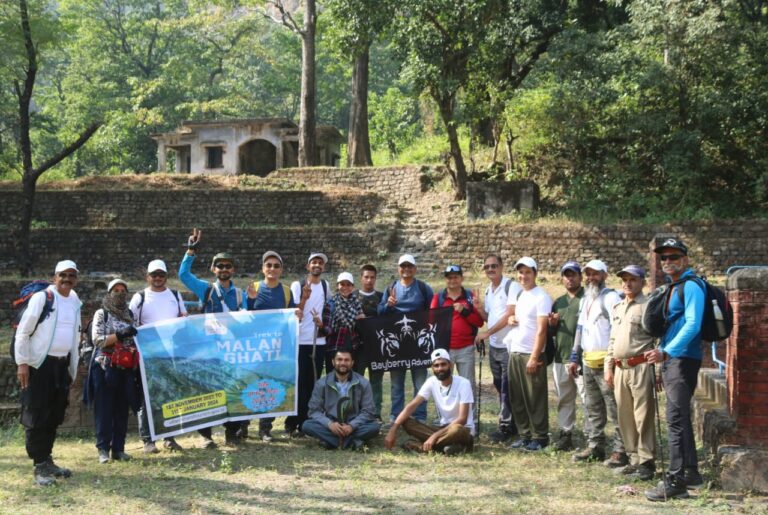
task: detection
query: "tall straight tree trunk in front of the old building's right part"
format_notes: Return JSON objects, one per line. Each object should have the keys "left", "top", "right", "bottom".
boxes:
{"left": 299, "top": 0, "right": 318, "bottom": 166}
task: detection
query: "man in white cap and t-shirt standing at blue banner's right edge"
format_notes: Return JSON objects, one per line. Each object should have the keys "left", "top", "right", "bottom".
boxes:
{"left": 285, "top": 252, "right": 333, "bottom": 438}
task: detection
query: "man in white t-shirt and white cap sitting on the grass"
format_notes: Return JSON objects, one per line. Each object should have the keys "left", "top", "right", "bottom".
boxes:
{"left": 384, "top": 349, "right": 475, "bottom": 455}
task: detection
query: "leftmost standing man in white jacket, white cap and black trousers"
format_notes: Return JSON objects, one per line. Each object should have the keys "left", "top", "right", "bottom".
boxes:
{"left": 14, "top": 260, "right": 82, "bottom": 486}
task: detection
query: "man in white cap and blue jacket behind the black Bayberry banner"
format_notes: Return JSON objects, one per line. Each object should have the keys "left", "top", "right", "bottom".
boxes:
{"left": 379, "top": 254, "right": 435, "bottom": 422}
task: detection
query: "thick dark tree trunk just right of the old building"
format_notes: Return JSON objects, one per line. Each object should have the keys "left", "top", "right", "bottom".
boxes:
{"left": 347, "top": 46, "right": 373, "bottom": 166}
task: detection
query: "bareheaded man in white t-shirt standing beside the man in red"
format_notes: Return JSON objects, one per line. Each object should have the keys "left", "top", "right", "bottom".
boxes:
{"left": 476, "top": 254, "right": 521, "bottom": 443}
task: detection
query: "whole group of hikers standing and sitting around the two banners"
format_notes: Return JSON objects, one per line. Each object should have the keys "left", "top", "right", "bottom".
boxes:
{"left": 15, "top": 229, "right": 704, "bottom": 500}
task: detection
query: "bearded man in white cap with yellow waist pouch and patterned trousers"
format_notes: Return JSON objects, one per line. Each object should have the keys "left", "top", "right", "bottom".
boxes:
{"left": 568, "top": 259, "right": 629, "bottom": 468}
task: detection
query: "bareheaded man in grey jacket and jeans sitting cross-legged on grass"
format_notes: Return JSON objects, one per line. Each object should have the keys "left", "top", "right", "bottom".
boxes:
{"left": 301, "top": 348, "right": 381, "bottom": 450}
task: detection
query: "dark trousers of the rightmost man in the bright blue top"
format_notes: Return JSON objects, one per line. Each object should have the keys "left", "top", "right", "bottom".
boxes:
{"left": 661, "top": 358, "right": 701, "bottom": 478}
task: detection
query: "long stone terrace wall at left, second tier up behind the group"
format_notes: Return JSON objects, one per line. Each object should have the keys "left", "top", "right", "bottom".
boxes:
{"left": 0, "top": 190, "right": 384, "bottom": 228}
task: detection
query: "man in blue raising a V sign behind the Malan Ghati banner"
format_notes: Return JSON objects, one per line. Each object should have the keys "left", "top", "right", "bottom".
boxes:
{"left": 179, "top": 229, "right": 243, "bottom": 449}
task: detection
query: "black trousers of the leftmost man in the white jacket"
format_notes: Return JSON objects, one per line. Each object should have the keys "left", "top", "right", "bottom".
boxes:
{"left": 20, "top": 356, "right": 72, "bottom": 464}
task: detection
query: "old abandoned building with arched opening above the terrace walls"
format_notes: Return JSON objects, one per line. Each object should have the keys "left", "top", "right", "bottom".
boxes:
{"left": 152, "top": 118, "right": 344, "bottom": 177}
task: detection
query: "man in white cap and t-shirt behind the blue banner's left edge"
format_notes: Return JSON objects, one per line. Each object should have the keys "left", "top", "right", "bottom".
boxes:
{"left": 128, "top": 259, "right": 187, "bottom": 454}
